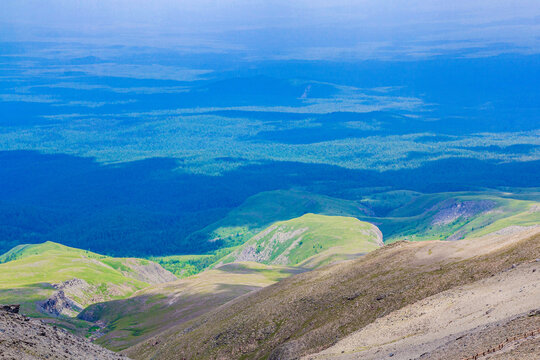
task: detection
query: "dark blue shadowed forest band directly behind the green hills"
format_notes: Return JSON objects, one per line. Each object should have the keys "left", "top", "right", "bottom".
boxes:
{"left": 0, "top": 151, "right": 540, "bottom": 256}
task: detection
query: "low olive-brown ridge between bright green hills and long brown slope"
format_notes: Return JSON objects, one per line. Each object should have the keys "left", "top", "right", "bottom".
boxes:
{"left": 79, "top": 262, "right": 301, "bottom": 350}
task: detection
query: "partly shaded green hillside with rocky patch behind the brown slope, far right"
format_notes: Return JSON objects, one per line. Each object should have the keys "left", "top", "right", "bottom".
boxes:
{"left": 360, "top": 191, "right": 540, "bottom": 243}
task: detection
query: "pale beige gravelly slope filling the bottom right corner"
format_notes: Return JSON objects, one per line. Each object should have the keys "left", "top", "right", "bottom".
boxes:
{"left": 305, "top": 261, "right": 540, "bottom": 360}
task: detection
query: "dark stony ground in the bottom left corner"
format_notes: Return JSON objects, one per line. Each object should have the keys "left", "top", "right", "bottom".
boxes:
{"left": 0, "top": 310, "right": 128, "bottom": 360}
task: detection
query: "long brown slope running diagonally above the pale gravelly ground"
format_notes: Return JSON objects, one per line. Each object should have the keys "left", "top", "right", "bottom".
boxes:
{"left": 126, "top": 227, "right": 540, "bottom": 359}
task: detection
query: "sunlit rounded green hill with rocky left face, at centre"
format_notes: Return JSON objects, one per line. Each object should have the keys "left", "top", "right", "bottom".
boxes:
{"left": 221, "top": 214, "right": 383, "bottom": 268}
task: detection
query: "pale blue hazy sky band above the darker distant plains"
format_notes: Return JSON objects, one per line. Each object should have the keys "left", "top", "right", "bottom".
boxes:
{"left": 0, "top": 0, "right": 540, "bottom": 59}
